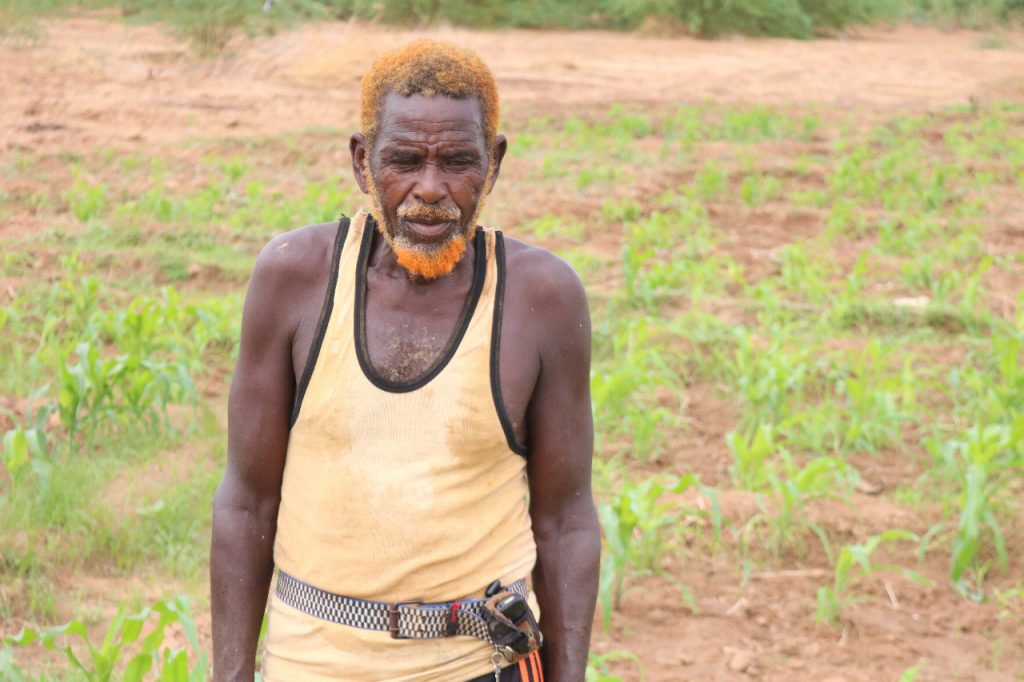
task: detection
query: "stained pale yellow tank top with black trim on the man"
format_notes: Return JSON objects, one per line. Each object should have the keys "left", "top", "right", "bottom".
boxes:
{"left": 263, "top": 212, "right": 540, "bottom": 682}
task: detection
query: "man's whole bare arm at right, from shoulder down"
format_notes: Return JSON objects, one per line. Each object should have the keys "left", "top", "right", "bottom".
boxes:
{"left": 526, "top": 259, "right": 601, "bottom": 682}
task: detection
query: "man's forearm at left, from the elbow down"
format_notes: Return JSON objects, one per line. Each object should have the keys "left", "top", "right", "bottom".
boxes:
{"left": 210, "top": 481, "right": 278, "bottom": 682}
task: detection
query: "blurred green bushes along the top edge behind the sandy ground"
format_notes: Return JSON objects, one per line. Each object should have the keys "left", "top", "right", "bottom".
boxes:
{"left": 6, "top": 0, "right": 1024, "bottom": 53}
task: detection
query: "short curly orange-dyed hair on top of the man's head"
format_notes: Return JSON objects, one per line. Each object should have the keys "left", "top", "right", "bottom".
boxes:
{"left": 360, "top": 39, "right": 499, "bottom": 152}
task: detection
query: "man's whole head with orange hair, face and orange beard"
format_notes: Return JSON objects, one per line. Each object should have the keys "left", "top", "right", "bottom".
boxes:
{"left": 350, "top": 40, "right": 506, "bottom": 279}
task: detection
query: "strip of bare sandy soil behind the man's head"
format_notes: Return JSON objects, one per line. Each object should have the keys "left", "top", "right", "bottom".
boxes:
{"left": 0, "top": 18, "right": 1024, "bottom": 148}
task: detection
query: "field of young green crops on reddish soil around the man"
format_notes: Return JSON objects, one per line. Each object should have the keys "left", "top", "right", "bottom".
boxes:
{"left": 0, "top": 95, "right": 1024, "bottom": 680}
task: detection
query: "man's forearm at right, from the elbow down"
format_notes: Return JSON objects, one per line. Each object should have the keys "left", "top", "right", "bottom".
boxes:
{"left": 534, "top": 514, "right": 601, "bottom": 682}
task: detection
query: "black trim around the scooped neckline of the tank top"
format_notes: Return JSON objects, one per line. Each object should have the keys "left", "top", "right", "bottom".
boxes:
{"left": 352, "top": 218, "right": 487, "bottom": 393}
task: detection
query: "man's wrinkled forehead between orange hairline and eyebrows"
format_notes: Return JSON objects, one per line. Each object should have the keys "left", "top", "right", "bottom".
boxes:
{"left": 377, "top": 92, "right": 484, "bottom": 143}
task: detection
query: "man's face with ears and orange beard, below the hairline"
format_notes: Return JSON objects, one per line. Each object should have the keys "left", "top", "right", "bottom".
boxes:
{"left": 352, "top": 93, "right": 504, "bottom": 280}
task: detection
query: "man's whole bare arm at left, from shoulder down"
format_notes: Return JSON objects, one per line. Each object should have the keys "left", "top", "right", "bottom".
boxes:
{"left": 210, "top": 235, "right": 298, "bottom": 682}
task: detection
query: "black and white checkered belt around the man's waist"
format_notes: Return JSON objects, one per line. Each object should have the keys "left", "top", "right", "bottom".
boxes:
{"left": 276, "top": 570, "right": 528, "bottom": 642}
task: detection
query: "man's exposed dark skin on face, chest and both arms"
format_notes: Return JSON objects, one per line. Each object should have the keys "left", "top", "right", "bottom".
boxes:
{"left": 211, "top": 94, "right": 600, "bottom": 682}
